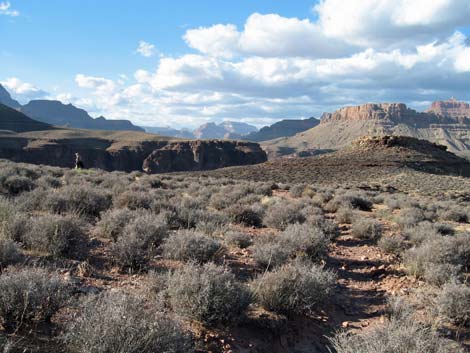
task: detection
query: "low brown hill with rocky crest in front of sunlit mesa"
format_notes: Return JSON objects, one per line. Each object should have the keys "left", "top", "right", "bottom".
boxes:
{"left": 211, "top": 136, "right": 470, "bottom": 187}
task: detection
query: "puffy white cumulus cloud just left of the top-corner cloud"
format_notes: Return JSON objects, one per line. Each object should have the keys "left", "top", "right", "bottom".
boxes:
{"left": 183, "top": 13, "right": 353, "bottom": 58}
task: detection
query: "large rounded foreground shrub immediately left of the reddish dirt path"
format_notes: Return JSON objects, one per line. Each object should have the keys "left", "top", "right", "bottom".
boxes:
{"left": 253, "top": 261, "right": 335, "bottom": 316}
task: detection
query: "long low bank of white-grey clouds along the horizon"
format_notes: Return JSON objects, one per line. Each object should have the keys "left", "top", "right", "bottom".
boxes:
{"left": 70, "top": 28, "right": 470, "bottom": 127}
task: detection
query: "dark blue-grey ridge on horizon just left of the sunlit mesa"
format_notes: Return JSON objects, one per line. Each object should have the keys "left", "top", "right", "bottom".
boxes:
{"left": 243, "top": 118, "right": 320, "bottom": 142}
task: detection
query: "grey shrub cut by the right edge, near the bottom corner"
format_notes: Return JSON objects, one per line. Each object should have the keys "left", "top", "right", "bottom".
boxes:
{"left": 436, "top": 282, "right": 470, "bottom": 326}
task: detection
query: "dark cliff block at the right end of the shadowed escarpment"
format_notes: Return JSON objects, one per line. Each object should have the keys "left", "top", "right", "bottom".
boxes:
{"left": 143, "top": 140, "right": 267, "bottom": 173}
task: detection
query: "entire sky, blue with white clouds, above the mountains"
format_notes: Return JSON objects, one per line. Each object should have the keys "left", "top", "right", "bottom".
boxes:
{"left": 0, "top": 0, "right": 470, "bottom": 128}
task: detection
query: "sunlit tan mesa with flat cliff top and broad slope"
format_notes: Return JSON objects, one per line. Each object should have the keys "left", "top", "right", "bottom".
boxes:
{"left": 263, "top": 103, "right": 470, "bottom": 157}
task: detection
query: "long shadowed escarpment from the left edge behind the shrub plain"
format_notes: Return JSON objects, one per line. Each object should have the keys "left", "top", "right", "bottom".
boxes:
{"left": 0, "top": 129, "right": 266, "bottom": 173}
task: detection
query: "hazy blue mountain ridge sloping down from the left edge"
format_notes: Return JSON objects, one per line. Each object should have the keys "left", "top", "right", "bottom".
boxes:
{"left": 0, "top": 85, "right": 144, "bottom": 131}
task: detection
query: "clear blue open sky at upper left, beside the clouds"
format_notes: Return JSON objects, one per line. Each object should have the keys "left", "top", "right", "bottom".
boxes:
{"left": 0, "top": 0, "right": 313, "bottom": 90}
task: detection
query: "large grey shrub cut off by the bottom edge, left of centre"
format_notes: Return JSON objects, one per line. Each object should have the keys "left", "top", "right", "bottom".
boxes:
{"left": 63, "top": 292, "right": 194, "bottom": 353}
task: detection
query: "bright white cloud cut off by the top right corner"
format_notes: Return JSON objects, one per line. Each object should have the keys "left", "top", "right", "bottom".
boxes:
{"left": 314, "top": 0, "right": 470, "bottom": 48}
